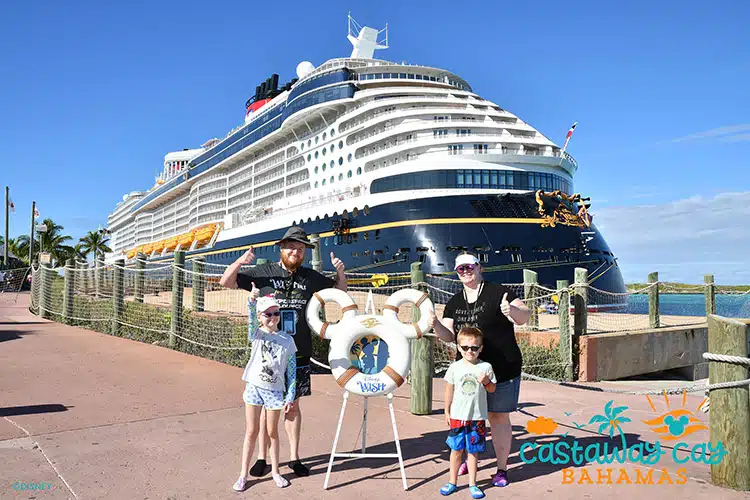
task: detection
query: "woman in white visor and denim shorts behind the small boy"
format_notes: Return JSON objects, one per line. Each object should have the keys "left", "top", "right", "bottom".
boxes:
{"left": 430, "top": 253, "right": 531, "bottom": 486}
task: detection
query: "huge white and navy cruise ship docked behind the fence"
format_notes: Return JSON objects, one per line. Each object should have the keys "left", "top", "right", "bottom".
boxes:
{"left": 107, "top": 17, "right": 625, "bottom": 292}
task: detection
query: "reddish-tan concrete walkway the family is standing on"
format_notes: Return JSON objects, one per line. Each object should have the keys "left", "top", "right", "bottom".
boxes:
{"left": 0, "top": 295, "right": 750, "bottom": 500}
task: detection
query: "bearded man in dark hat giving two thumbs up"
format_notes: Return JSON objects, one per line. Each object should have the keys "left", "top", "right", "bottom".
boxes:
{"left": 219, "top": 227, "right": 346, "bottom": 477}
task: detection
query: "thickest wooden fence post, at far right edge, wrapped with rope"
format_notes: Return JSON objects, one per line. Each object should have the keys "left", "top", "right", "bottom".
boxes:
{"left": 708, "top": 314, "right": 750, "bottom": 491}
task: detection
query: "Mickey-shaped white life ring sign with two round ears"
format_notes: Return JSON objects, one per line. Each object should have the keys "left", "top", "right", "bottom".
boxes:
{"left": 306, "top": 288, "right": 433, "bottom": 396}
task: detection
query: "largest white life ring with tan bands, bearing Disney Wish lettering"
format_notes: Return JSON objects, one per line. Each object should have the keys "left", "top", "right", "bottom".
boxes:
{"left": 328, "top": 314, "right": 411, "bottom": 397}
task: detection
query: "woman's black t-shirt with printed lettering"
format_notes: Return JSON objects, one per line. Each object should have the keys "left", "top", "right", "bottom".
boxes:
{"left": 443, "top": 282, "right": 522, "bottom": 382}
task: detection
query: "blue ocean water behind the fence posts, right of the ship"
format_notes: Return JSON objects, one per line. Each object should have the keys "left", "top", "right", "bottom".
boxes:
{"left": 622, "top": 294, "right": 750, "bottom": 318}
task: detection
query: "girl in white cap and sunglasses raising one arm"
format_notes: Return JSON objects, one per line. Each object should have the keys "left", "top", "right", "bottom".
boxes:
{"left": 233, "top": 283, "right": 297, "bottom": 491}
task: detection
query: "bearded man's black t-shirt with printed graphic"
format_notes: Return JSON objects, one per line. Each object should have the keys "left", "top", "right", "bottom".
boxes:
{"left": 237, "top": 262, "right": 334, "bottom": 358}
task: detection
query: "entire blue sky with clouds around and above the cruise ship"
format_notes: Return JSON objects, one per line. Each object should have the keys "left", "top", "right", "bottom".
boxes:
{"left": 0, "top": 0, "right": 750, "bottom": 284}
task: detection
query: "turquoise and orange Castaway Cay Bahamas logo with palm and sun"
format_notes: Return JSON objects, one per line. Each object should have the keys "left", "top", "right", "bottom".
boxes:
{"left": 519, "top": 392, "right": 727, "bottom": 484}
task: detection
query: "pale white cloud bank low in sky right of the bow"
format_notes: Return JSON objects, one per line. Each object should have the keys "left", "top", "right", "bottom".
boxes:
{"left": 593, "top": 191, "right": 750, "bottom": 284}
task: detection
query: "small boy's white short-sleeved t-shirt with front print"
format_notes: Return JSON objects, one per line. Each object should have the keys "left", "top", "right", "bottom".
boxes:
{"left": 445, "top": 359, "right": 497, "bottom": 420}
